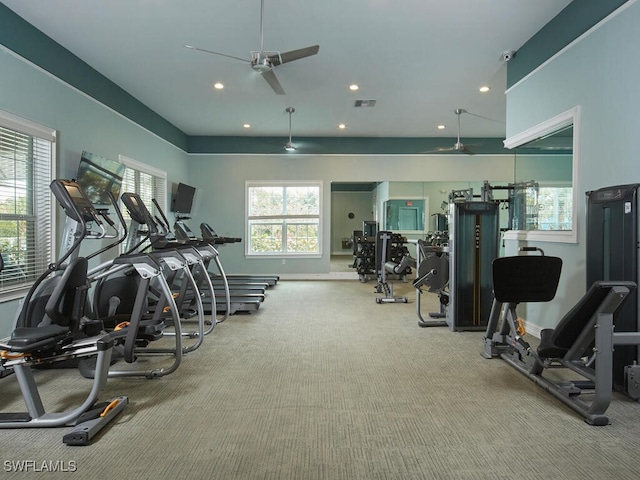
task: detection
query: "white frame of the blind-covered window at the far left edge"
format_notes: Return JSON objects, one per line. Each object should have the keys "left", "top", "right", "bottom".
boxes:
{"left": 0, "top": 111, "right": 57, "bottom": 302}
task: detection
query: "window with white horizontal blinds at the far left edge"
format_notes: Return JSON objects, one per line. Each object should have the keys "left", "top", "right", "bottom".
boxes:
{"left": 0, "top": 112, "right": 55, "bottom": 299}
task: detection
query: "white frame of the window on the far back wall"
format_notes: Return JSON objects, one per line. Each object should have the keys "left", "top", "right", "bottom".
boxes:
{"left": 244, "top": 180, "right": 324, "bottom": 258}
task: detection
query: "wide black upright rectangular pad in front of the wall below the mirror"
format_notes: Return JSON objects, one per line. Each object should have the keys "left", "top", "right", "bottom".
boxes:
{"left": 493, "top": 255, "right": 562, "bottom": 303}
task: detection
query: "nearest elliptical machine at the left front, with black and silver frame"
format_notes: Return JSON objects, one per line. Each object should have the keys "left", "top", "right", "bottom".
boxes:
{"left": 0, "top": 180, "right": 128, "bottom": 445}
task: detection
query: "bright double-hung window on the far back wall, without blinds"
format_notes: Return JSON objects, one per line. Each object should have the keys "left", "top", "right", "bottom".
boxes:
{"left": 246, "top": 182, "right": 322, "bottom": 256}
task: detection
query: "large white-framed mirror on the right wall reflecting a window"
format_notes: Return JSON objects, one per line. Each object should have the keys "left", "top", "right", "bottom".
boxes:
{"left": 504, "top": 107, "right": 579, "bottom": 243}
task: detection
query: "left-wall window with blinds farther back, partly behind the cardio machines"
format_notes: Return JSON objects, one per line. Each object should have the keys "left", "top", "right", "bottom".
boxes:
{"left": 119, "top": 155, "right": 167, "bottom": 249}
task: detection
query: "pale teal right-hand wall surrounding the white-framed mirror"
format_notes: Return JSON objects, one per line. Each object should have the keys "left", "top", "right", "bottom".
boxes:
{"left": 507, "top": 1, "right": 640, "bottom": 327}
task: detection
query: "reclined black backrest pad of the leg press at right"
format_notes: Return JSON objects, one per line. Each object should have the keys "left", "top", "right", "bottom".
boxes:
{"left": 551, "top": 281, "right": 635, "bottom": 348}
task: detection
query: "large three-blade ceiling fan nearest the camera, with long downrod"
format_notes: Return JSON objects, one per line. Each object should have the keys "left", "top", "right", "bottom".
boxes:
{"left": 185, "top": 0, "right": 320, "bottom": 95}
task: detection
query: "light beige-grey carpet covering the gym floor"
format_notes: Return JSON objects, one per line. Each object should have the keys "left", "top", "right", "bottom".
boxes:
{"left": 0, "top": 281, "right": 640, "bottom": 480}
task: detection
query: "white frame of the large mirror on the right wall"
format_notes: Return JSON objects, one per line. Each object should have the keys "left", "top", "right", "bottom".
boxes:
{"left": 504, "top": 106, "right": 580, "bottom": 243}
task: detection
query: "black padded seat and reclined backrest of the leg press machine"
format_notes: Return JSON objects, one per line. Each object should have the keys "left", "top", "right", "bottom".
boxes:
{"left": 537, "top": 282, "right": 635, "bottom": 359}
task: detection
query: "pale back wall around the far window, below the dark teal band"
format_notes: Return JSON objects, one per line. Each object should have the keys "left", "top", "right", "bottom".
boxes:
{"left": 189, "top": 154, "right": 514, "bottom": 274}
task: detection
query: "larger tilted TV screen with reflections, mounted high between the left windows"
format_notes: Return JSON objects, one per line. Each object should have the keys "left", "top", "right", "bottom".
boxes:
{"left": 76, "top": 152, "right": 126, "bottom": 205}
